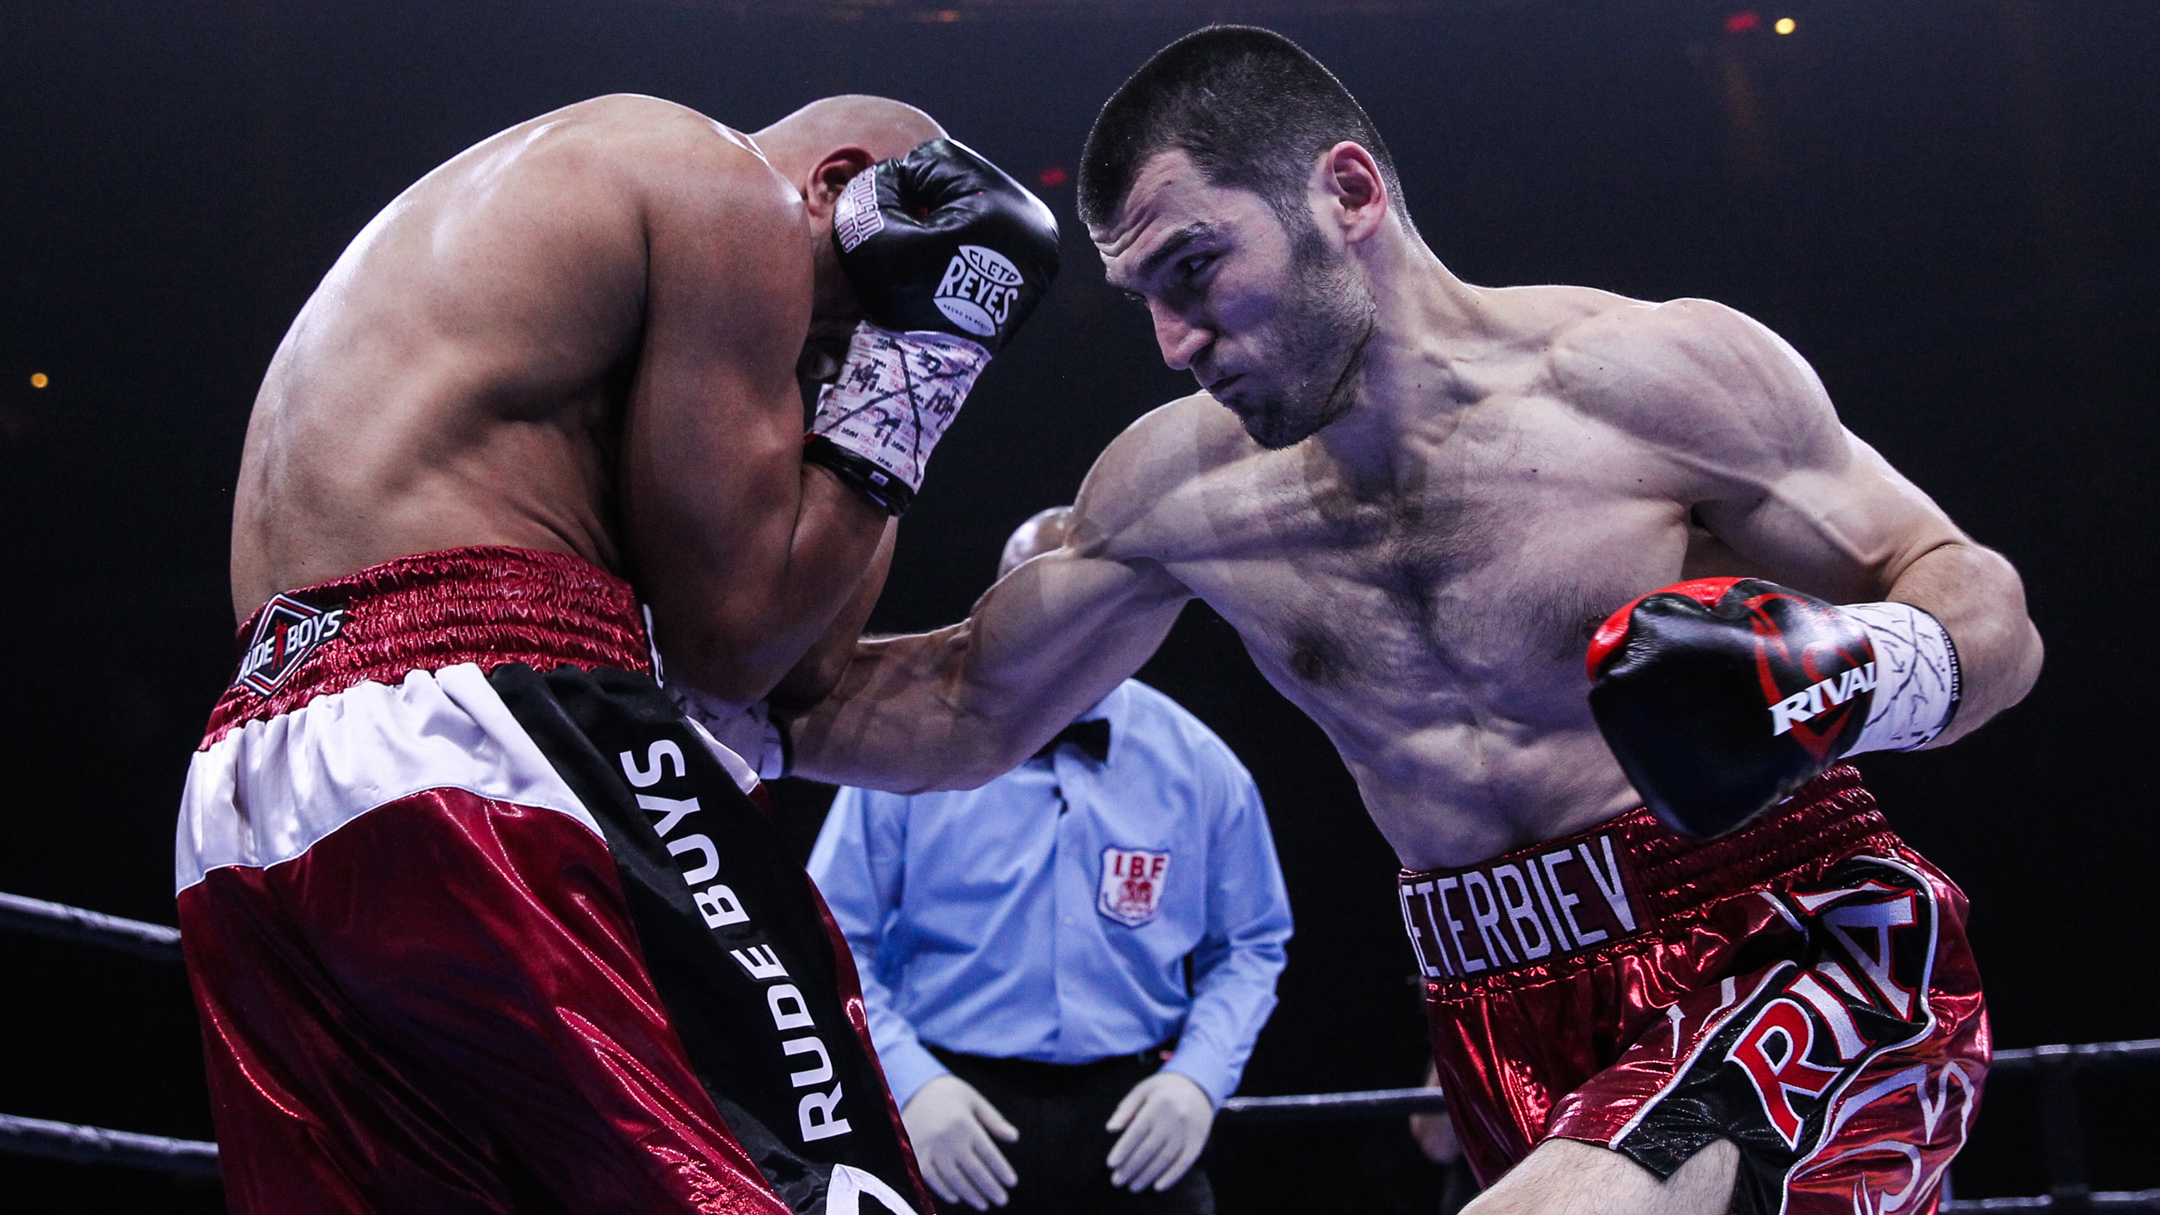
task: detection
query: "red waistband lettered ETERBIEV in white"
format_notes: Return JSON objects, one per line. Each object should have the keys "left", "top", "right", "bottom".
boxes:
{"left": 1400, "top": 765, "right": 1896, "bottom": 982}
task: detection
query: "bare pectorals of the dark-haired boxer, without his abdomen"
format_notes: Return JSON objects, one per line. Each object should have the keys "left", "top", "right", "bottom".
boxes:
{"left": 1194, "top": 398, "right": 1685, "bottom": 683}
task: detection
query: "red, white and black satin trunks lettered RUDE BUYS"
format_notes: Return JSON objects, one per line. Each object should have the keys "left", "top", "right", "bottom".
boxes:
{"left": 175, "top": 549, "right": 931, "bottom": 1215}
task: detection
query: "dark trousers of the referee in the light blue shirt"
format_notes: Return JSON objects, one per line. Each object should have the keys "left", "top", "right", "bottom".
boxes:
{"left": 931, "top": 1046, "right": 1214, "bottom": 1215}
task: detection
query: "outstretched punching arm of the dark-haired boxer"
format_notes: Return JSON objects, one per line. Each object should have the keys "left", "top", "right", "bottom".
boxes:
{"left": 791, "top": 419, "right": 1192, "bottom": 793}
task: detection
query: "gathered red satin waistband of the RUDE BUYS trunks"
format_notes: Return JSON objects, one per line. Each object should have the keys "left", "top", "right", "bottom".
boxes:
{"left": 203, "top": 547, "right": 652, "bottom": 746}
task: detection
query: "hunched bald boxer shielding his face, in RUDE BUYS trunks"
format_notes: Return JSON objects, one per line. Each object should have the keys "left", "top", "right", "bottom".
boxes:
{"left": 175, "top": 97, "right": 1056, "bottom": 1215}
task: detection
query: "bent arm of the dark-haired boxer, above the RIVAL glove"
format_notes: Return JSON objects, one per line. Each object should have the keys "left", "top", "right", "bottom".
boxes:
{"left": 1596, "top": 301, "right": 2041, "bottom": 746}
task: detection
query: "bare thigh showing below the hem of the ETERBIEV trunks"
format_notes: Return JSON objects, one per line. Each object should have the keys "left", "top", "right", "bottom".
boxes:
{"left": 1462, "top": 1139, "right": 1741, "bottom": 1215}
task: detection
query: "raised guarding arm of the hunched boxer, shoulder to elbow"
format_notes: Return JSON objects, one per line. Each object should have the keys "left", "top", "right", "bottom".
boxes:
{"left": 622, "top": 138, "right": 886, "bottom": 703}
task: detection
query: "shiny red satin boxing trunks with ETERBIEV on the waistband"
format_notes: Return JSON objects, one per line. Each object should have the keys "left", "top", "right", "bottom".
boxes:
{"left": 1400, "top": 767, "right": 1989, "bottom": 1215}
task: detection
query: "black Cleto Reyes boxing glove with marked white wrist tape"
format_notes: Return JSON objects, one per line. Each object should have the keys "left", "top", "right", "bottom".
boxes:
{"left": 804, "top": 138, "right": 1058, "bottom": 515}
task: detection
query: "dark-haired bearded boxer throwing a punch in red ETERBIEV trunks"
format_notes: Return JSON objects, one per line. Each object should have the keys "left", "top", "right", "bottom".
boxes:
{"left": 795, "top": 26, "right": 2041, "bottom": 1215}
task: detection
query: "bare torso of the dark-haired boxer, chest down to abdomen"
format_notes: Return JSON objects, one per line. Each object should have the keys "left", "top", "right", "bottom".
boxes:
{"left": 1140, "top": 382, "right": 1687, "bottom": 847}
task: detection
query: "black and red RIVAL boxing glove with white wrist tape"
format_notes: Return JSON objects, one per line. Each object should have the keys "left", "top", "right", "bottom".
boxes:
{"left": 1588, "top": 577, "right": 1959, "bottom": 837}
